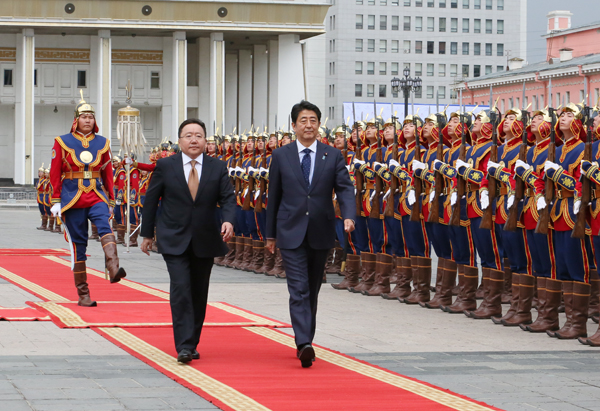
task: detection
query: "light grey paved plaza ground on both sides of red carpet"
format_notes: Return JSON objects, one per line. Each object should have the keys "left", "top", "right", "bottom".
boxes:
{"left": 0, "top": 208, "right": 600, "bottom": 411}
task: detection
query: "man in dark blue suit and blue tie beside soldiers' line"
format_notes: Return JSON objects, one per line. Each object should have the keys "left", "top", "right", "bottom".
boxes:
{"left": 267, "top": 101, "right": 356, "bottom": 368}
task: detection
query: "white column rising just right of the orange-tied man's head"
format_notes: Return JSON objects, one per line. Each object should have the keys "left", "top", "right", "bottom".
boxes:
{"left": 206, "top": 33, "right": 225, "bottom": 134}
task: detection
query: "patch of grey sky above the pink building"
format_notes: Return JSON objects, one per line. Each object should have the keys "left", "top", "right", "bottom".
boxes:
{"left": 527, "top": 0, "right": 600, "bottom": 64}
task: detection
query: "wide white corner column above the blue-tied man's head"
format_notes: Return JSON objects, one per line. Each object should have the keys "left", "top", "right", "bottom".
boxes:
{"left": 277, "top": 34, "right": 305, "bottom": 121}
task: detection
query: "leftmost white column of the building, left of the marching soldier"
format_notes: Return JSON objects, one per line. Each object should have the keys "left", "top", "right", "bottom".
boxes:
{"left": 13, "top": 29, "right": 35, "bottom": 184}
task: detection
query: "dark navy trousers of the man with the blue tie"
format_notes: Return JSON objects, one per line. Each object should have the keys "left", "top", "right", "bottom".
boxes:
{"left": 280, "top": 239, "right": 329, "bottom": 346}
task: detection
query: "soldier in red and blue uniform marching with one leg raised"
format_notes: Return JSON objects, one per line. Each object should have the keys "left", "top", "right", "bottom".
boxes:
{"left": 50, "top": 96, "right": 126, "bottom": 307}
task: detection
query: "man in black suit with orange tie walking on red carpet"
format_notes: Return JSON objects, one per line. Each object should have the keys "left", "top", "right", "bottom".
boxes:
{"left": 140, "top": 119, "right": 235, "bottom": 363}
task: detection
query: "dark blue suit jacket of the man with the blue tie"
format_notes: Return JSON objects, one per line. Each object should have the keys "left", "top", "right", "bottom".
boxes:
{"left": 266, "top": 142, "right": 356, "bottom": 249}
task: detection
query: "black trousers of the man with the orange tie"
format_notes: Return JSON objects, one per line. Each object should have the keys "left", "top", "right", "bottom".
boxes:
{"left": 163, "top": 243, "right": 213, "bottom": 352}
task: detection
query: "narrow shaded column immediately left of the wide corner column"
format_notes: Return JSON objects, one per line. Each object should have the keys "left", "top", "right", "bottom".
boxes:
{"left": 252, "top": 44, "right": 269, "bottom": 132}
